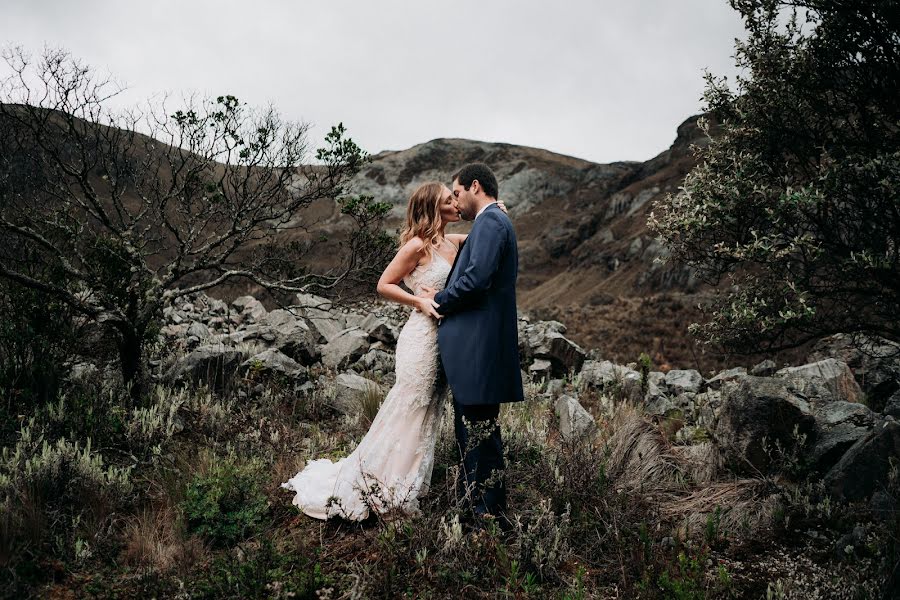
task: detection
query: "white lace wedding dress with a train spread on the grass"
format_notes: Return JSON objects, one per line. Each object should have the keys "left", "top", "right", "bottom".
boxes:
{"left": 281, "top": 251, "right": 450, "bottom": 521}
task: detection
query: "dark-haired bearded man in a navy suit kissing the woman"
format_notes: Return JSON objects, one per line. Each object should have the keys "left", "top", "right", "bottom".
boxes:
{"left": 426, "top": 163, "right": 524, "bottom": 517}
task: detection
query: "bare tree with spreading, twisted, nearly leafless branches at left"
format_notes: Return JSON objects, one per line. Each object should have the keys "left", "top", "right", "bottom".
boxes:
{"left": 0, "top": 49, "right": 394, "bottom": 399}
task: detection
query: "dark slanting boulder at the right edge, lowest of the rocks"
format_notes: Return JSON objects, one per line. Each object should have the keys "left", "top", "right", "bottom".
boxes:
{"left": 825, "top": 420, "right": 900, "bottom": 501}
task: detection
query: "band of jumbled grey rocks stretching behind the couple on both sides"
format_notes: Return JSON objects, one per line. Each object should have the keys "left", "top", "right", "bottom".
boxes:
{"left": 163, "top": 294, "right": 900, "bottom": 502}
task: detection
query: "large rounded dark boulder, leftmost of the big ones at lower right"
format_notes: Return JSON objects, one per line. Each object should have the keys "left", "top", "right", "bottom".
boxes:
{"left": 715, "top": 376, "right": 816, "bottom": 473}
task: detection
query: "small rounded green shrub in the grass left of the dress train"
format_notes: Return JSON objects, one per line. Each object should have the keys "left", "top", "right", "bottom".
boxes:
{"left": 181, "top": 457, "right": 269, "bottom": 547}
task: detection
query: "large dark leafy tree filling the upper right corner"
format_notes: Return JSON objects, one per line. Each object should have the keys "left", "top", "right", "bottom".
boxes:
{"left": 650, "top": 0, "right": 900, "bottom": 352}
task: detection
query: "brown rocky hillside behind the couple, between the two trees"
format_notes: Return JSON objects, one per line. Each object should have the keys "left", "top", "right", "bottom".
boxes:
{"left": 318, "top": 116, "right": 768, "bottom": 370}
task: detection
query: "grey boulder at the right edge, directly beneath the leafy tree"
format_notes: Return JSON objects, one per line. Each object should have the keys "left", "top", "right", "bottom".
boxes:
{"left": 808, "top": 333, "right": 900, "bottom": 411}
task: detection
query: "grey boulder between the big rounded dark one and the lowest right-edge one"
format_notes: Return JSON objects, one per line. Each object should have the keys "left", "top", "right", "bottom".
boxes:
{"left": 809, "top": 400, "right": 875, "bottom": 472}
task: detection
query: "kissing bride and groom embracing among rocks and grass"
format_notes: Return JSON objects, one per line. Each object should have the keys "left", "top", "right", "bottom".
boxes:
{"left": 282, "top": 163, "right": 524, "bottom": 521}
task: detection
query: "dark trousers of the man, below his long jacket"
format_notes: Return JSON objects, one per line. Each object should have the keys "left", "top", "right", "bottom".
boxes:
{"left": 453, "top": 401, "right": 506, "bottom": 515}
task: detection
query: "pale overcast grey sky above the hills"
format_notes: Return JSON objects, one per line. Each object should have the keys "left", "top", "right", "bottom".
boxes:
{"left": 0, "top": 0, "right": 743, "bottom": 162}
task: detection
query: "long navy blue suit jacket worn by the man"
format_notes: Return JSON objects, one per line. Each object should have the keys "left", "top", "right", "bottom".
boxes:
{"left": 434, "top": 204, "right": 524, "bottom": 405}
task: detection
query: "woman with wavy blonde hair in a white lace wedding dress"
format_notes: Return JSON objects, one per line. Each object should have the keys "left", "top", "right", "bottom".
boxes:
{"left": 281, "top": 182, "right": 505, "bottom": 521}
